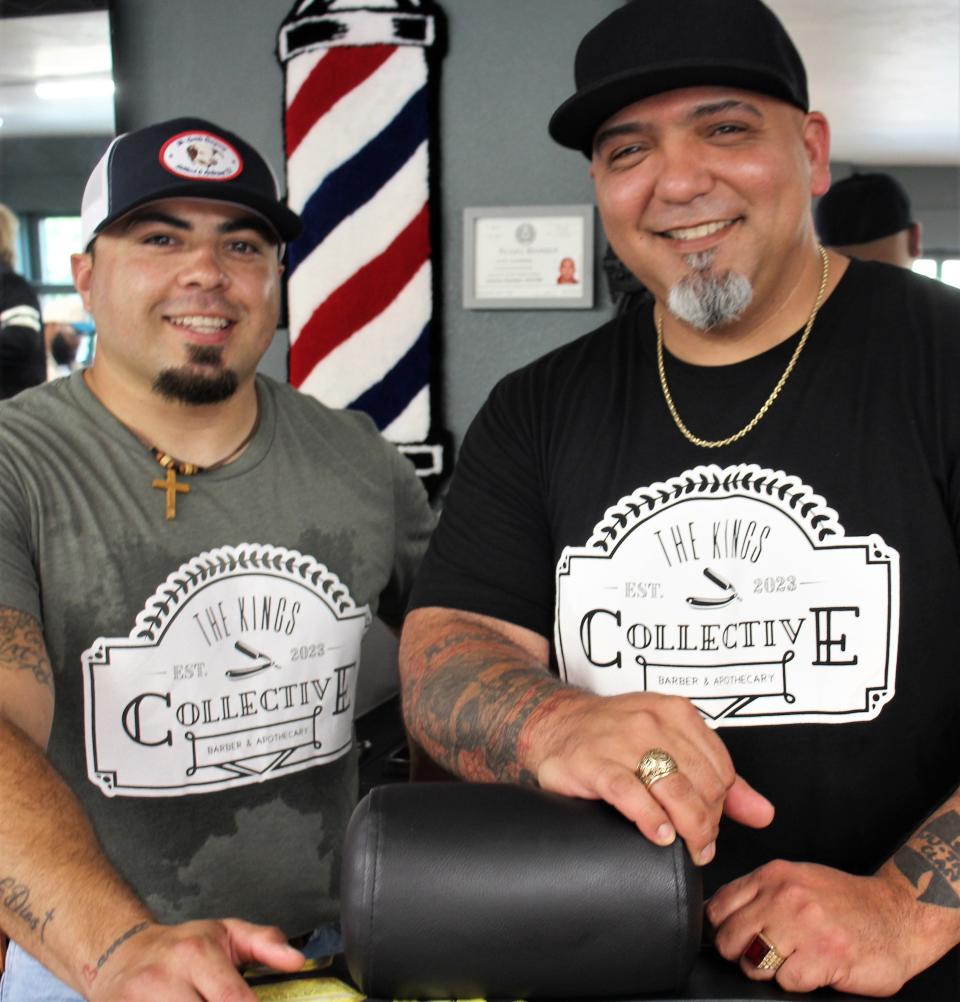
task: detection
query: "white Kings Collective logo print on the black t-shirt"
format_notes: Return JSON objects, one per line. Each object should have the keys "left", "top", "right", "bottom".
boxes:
{"left": 554, "top": 466, "right": 900, "bottom": 725}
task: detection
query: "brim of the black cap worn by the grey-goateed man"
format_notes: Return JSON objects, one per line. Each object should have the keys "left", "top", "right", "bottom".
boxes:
{"left": 548, "top": 59, "right": 808, "bottom": 156}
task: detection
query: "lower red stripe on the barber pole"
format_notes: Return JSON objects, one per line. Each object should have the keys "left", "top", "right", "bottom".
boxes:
{"left": 290, "top": 203, "right": 430, "bottom": 386}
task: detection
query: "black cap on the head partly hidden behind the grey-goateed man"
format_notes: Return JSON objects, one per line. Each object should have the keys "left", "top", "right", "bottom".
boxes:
{"left": 814, "top": 173, "right": 914, "bottom": 247}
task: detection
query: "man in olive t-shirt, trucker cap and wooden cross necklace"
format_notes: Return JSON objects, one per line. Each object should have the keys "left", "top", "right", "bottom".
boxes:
{"left": 0, "top": 118, "right": 433, "bottom": 1002}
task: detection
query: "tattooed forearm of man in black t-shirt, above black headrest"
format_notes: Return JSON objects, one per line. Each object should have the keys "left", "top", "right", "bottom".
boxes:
{"left": 400, "top": 610, "right": 582, "bottom": 783}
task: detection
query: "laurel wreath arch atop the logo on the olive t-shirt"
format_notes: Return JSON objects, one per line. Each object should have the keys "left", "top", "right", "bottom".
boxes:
{"left": 130, "top": 543, "right": 357, "bottom": 642}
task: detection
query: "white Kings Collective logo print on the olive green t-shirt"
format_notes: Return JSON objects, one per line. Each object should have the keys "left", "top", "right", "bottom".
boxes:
{"left": 81, "top": 543, "right": 371, "bottom": 797}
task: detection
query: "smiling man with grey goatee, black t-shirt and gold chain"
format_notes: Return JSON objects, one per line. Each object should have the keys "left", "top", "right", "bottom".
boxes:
{"left": 401, "top": 0, "right": 960, "bottom": 994}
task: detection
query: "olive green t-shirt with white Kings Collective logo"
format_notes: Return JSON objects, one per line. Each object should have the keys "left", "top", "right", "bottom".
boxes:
{"left": 0, "top": 374, "right": 433, "bottom": 935}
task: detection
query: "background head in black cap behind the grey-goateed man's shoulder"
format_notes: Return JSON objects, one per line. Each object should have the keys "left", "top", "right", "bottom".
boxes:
{"left": 814, "top": 173, "right": 921, "bottom": 268}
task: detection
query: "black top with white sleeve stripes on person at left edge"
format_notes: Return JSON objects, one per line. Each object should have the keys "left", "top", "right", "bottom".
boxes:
{"left": 0, "top": 266, "right": 47, "bottom": 399}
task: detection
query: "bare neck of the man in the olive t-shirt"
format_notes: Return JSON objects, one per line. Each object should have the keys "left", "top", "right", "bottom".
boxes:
{"left": 84, "top": 366, "right": 259, "bottom": 467}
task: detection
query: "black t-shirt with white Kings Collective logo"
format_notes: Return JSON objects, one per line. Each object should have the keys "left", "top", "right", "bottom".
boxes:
{"left": 413, "top": 262, "right": 960, "bottom": 891}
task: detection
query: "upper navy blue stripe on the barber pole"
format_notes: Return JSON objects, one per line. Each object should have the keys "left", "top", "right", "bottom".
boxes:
{"left": 287, "top": 88, "right": 427, "bottom": 274}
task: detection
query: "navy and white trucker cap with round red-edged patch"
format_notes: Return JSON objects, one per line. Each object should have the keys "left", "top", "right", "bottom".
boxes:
{"left": 80, "top": 118, "right": 303, "bottom": 249}
